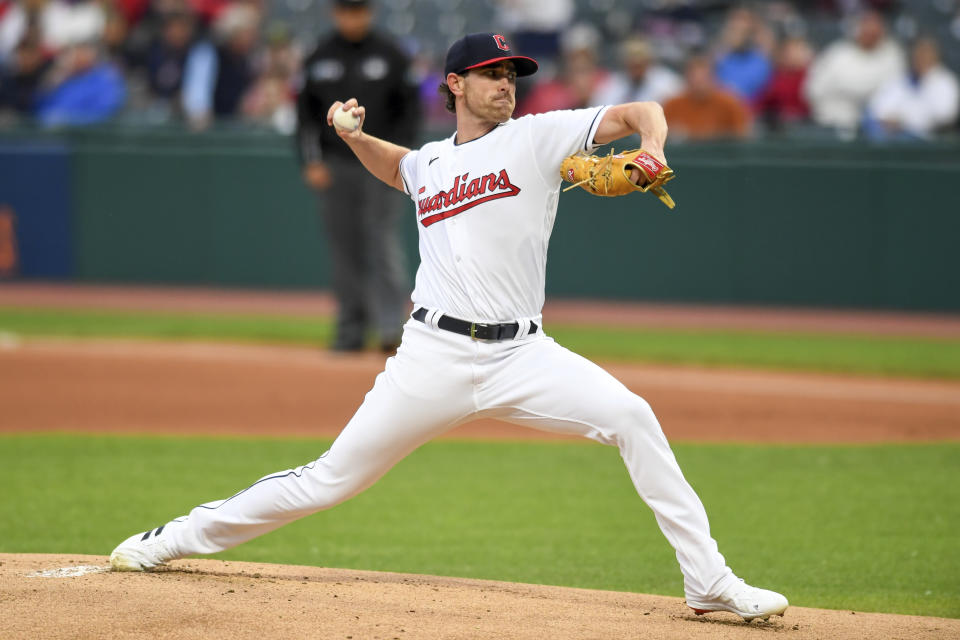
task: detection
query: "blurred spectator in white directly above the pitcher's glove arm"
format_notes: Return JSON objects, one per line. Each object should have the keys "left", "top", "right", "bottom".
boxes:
{"left": 593, "top": 37, "right": 683, "bottom": 104}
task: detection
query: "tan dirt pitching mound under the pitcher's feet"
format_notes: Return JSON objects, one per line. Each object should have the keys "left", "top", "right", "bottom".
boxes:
{"left": 0, "top": 554, "right": 960, "bottom": 640}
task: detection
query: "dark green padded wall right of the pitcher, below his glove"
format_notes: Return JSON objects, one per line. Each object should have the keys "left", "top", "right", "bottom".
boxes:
{"left": 548, "top": 145, "right": 960, "bottom": 311}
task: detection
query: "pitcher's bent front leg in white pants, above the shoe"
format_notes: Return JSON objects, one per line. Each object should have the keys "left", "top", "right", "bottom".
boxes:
{"left": 481, "top": 338, "right": 736, "bottom": 597}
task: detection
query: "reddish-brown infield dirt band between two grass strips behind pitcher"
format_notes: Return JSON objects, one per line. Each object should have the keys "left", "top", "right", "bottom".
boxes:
{"left": 0, "top": 339, "right": 960, "bottom": 443}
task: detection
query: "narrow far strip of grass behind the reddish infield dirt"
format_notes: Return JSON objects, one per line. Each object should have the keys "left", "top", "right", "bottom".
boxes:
{"left": 0, "top": 308, "right": 960, "bottom": 379}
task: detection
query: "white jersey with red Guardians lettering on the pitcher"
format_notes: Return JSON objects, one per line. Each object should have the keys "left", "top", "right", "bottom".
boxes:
{"left": 400, "top": 107, "right": 607, "bottom": 322}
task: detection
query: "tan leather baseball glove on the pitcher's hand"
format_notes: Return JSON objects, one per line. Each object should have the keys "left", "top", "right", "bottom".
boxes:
{"left": 560, "top": 149, "right": 676, "bottom": 209}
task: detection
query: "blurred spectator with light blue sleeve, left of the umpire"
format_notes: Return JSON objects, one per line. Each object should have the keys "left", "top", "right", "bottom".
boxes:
{"left": 183, "top": 2, "right": 260, "bottom": 129}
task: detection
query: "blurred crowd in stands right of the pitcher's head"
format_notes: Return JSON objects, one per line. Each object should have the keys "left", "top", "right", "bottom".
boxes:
{"left": 506, "top": 2, "right": 960, "bottom": 140}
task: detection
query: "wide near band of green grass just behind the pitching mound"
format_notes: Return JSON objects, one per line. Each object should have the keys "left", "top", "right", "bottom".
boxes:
{"left": 0, "top": 435, "right": 960, "bottom": 617}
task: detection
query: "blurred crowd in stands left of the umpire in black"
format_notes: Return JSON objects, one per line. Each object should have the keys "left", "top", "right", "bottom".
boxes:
{"left": 0, "top": 0, "right": 300, "bottom": 133}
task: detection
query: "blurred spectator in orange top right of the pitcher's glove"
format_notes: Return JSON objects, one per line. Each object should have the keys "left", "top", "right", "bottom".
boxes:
{"left": 663, "top": 55, "right": 750, "bottom": 140}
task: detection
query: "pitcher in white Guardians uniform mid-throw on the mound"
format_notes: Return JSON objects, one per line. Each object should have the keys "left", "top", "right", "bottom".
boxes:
{"left": 110, "top": 33, "right": 787, "bottom": 622}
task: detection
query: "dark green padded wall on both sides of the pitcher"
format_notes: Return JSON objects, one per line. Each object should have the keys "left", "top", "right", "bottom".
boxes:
{"left": 0, "top": 131, "right": 960, "bottom": 311}
